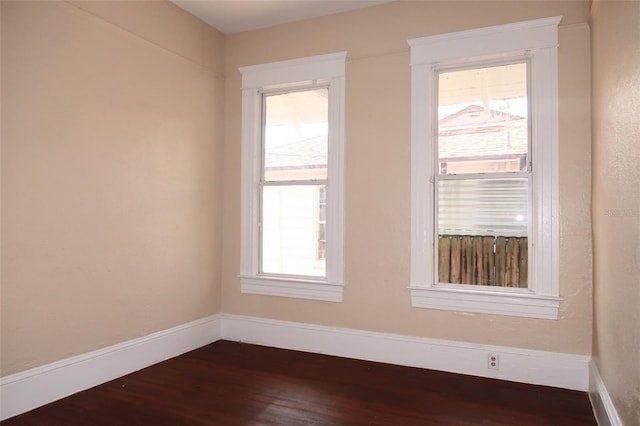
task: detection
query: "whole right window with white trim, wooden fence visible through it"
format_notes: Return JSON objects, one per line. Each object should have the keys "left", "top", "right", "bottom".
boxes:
{"left": 409, "top": 17, "right": 560, "bottom": 319}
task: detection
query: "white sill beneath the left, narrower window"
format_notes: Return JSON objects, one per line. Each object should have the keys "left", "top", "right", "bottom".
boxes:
{"left": 240, "top": 275, "right": 344, "bottom": 302}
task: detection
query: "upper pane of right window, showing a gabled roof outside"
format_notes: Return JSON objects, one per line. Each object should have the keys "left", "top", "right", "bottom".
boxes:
{"left": 438, "top": 63, "right": 529, "bottom": 174}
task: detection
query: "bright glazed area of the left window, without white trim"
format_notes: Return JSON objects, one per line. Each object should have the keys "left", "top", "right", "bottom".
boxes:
{"left": 258, "top": 85, "right": 329, "bottom": 277}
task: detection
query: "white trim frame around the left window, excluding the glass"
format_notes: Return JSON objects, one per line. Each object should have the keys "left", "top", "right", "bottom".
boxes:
{"left": 239, "top": 52, "right": 347, "bottom": 302}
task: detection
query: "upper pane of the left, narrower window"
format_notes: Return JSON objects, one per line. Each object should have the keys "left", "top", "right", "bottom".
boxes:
{"left": 264, "top": 88, "right": 329, "bottom": 181}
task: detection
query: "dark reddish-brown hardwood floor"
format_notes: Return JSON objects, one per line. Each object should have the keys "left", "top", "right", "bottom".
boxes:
{"left": 2, "top": 341, "right": 596, "bottom": 426}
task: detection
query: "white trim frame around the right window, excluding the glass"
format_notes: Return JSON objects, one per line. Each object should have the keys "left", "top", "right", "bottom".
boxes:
{"left": 408, "top": 16, "right": 562, "bottom": 319}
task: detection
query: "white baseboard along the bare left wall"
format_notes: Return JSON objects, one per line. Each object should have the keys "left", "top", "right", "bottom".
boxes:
{"left": 0, "top": 314, "right": 220, "bottom": 420}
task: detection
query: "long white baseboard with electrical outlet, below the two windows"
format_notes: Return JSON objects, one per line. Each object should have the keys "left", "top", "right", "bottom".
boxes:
{"left": 221, "top": 314, "right": 590, "bottom": 392}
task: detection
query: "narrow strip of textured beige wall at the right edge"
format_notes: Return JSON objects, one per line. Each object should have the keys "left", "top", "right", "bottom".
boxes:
{"left": 591, "top": 1, "right": 640, "bottom": 425}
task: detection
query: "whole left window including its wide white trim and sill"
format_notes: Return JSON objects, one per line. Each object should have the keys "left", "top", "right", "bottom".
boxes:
{"left": 240, "top": 52, "right": 346, "bottom": 301}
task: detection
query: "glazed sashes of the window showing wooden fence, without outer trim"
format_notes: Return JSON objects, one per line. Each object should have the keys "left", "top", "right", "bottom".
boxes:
{"left": 433, "top": 60, "right": 531, "bottom": 288}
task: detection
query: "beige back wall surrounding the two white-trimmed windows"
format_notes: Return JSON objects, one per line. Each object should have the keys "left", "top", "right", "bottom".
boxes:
{"left": 222, "top": 1, "right": 592, "bottom": 354}
